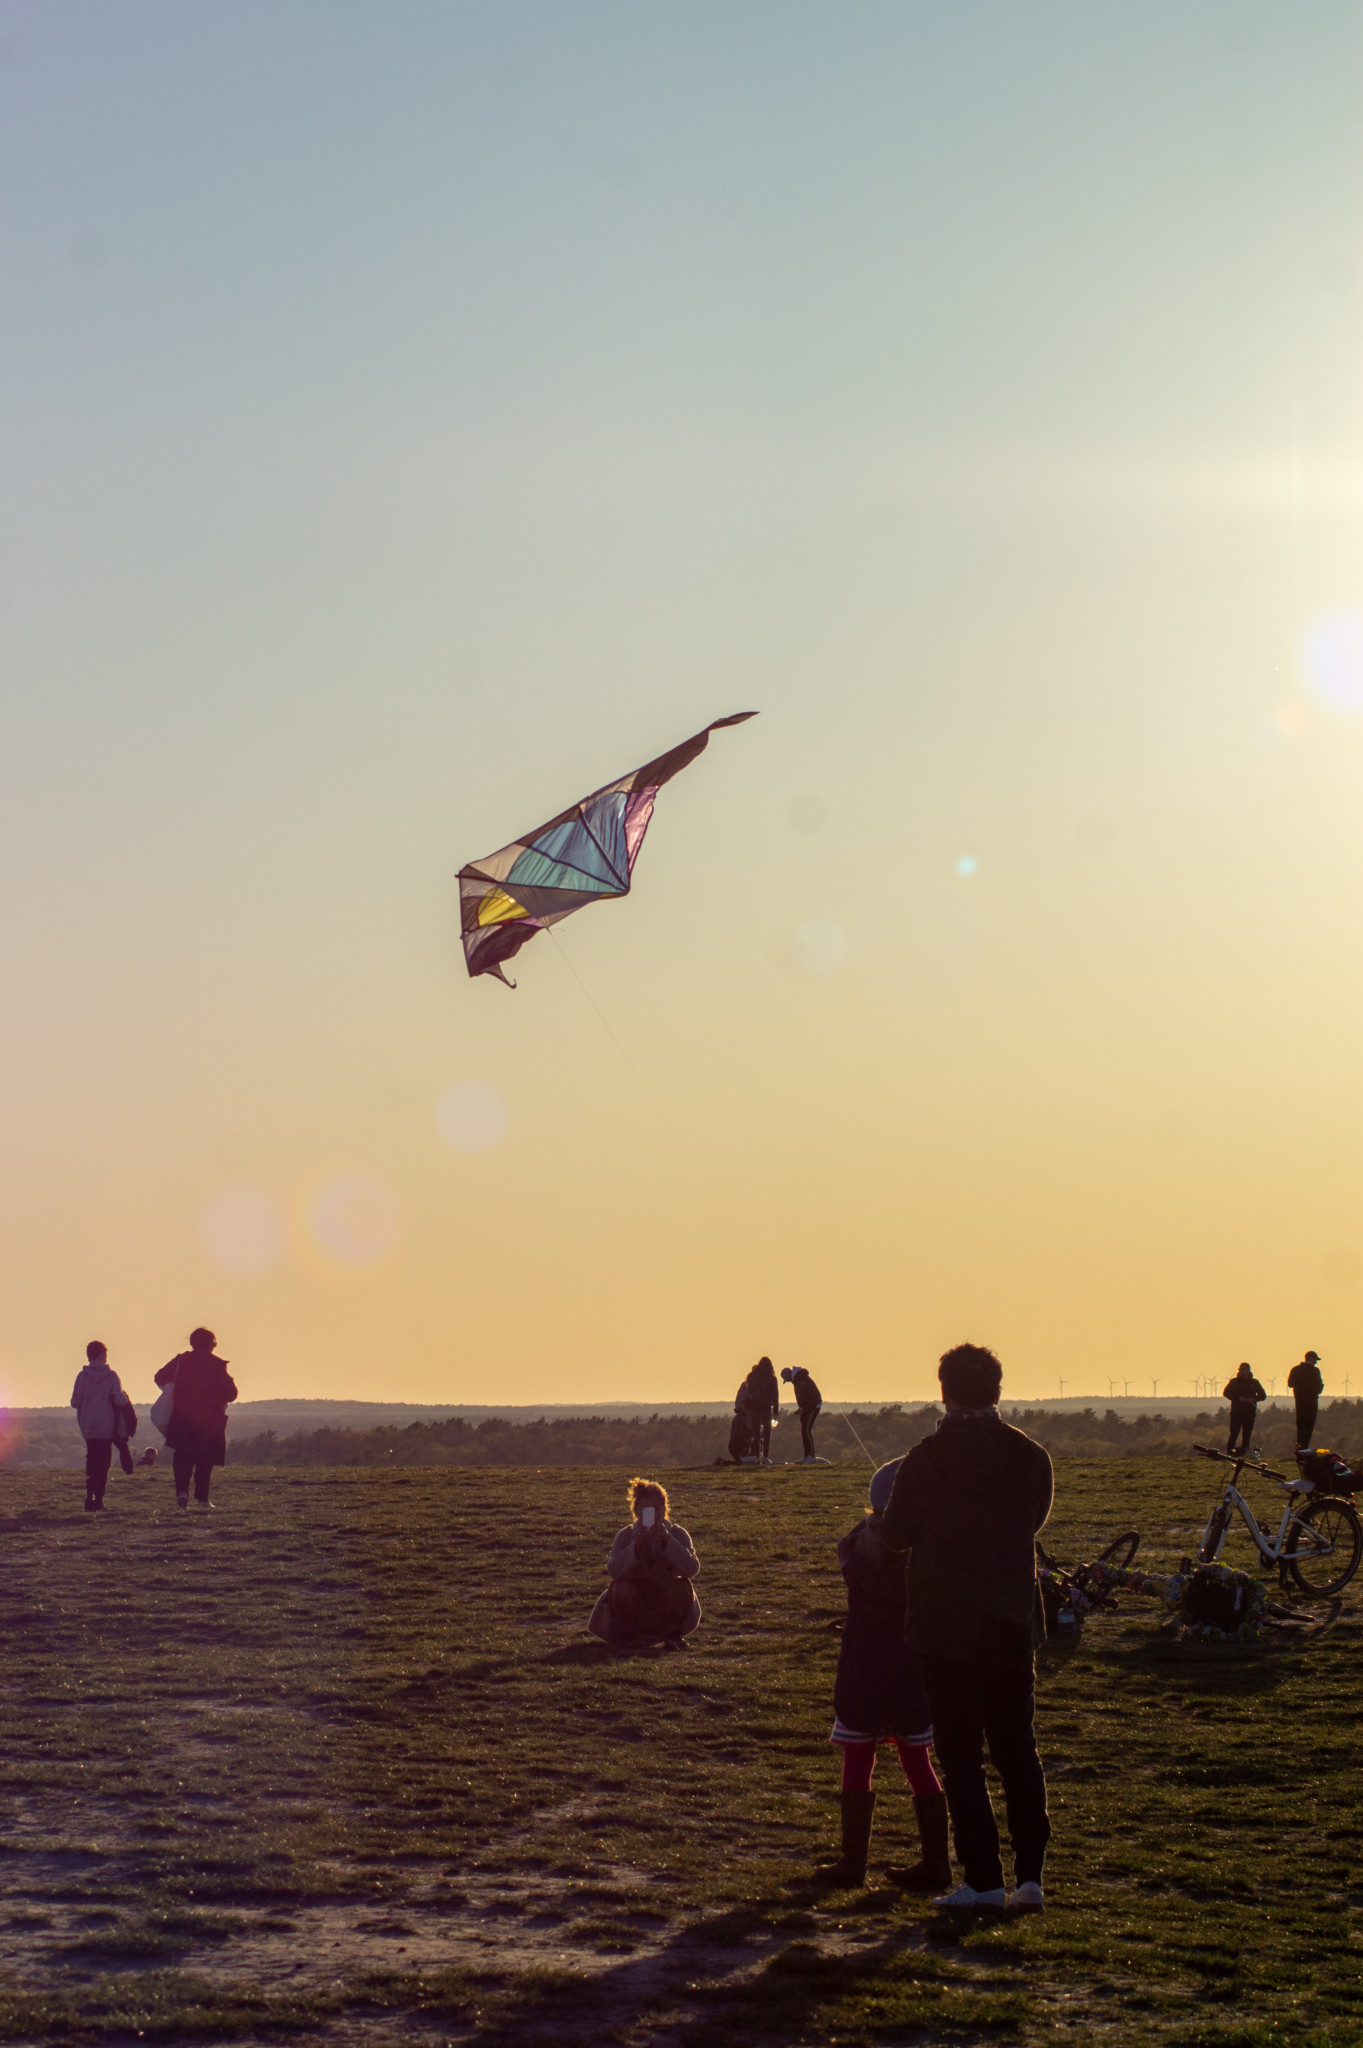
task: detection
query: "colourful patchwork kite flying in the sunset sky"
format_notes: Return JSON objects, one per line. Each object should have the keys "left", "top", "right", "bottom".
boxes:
{"left": 458, "top": 711, "right": 757, "bottom": 989}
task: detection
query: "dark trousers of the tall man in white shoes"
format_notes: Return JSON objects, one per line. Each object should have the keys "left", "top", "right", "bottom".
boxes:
{"left": 923, "top": 1651, "right": 1050, "bottom": 1892}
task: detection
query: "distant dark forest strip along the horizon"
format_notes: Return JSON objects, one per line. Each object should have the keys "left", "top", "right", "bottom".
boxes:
{"left": 0, "top": 1401, "right": 1363, "bottom": 1470}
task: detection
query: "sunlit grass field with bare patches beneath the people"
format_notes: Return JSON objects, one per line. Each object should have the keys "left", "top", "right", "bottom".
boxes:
{"left": 0, "top": 1458, "right": 1363, "bottom": 2048}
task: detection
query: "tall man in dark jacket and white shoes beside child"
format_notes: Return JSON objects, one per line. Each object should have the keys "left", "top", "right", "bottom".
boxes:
{"left": 882, "top": 1343, "right": 1054, "bottom": 1913}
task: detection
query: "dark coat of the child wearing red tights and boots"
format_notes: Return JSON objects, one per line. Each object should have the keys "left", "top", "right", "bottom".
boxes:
{"left": 833, "top": 1516, "right": 933, "bottom": 1739}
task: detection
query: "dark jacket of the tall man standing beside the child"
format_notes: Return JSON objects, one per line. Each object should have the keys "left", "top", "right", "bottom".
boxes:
{"left": 882, "top": 1411, "right": 1054, "bottom": 1663}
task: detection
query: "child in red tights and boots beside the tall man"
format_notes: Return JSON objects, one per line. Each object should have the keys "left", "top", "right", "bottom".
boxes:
{"left": 815, "top": 1458, "right": 952, "bottom": 1892}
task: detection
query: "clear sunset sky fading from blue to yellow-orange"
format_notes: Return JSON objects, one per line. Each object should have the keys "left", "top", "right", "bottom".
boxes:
{"left": 0, "top": 0, "right": 1363, "bottom": 1405}
